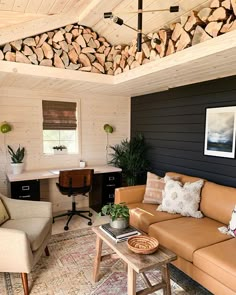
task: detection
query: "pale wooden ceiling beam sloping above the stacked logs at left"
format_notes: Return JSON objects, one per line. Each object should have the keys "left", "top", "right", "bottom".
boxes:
{"left": 0, "top": 0, "right": 102, "bottom": 45}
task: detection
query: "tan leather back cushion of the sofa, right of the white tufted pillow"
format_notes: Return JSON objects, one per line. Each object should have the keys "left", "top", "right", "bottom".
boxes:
{"left": 200, "top": 181, "right": 236, "bottom": 224}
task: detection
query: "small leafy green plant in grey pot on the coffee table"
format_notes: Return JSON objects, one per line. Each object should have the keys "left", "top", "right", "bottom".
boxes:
{"left": 99, "top": 203, "right": 129, "bottom": 229}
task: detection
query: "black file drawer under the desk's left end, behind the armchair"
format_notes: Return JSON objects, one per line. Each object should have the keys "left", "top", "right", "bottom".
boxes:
{"left": 10, "top": 180, "right": 40, "bottom": 201}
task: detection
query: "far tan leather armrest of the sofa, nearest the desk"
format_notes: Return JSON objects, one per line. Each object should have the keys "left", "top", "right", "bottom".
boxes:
{"left": 115, "top": 185, "right": 146, "bottom": 204}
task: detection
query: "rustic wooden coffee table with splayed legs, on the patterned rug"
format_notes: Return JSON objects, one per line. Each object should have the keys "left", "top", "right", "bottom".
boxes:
{"left": 93, "top": 226, "right": 177, "bottom": 295}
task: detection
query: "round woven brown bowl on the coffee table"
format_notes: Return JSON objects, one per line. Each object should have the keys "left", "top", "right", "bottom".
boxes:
{"left": 127, "top": 235, "right": 159, "bottom": 254}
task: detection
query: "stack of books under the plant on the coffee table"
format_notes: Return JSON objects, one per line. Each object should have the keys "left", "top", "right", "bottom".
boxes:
{"left": 100, "top": 223, "right": 141, "bottom": 243}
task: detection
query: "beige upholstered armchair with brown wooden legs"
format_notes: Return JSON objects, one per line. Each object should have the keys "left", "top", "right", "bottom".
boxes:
{"left": 0, "top": 194, "right": 52, "bottom": 295}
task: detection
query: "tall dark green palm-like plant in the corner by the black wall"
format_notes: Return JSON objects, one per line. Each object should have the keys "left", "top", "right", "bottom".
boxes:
{"left": 109, "top": 134, "right": 149, "bottom": 185}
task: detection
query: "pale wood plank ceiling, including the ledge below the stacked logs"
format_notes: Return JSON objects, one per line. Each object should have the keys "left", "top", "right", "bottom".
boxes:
{"left": 0, "top": 0, "right": 236, "bottom": 96}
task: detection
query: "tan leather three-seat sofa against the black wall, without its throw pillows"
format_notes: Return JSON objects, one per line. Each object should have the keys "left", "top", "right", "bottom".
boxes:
{"left": 115, "top": 172, "right": 236, "bottom": 295}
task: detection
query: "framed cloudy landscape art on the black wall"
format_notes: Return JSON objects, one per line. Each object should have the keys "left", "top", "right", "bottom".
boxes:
{"left": 204, "top": 106, "right": 236, "bottom": 158}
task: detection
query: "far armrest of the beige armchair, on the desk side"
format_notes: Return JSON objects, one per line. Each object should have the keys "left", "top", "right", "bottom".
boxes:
{"left": 1, "top": 195, "right": 52, "bottom": 219}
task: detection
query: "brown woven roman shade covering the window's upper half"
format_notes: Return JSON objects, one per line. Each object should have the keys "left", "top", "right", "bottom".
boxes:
{"left": 42, "top": 100, "right": 77, "bottom": 130}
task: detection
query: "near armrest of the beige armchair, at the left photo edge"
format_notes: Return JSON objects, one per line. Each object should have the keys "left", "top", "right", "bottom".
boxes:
{"left": 0, "top": 227, "right": 33, "bottom": 272}
